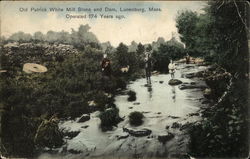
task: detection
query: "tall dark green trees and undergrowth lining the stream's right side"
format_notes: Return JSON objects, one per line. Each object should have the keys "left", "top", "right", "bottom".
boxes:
{"left": 176, "top": 0, "right": 249, "bottom": 158}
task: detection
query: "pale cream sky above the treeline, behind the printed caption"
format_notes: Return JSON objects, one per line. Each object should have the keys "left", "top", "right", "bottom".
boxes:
{"left": 0, "top": 1, "right": 206, "bottom": 46}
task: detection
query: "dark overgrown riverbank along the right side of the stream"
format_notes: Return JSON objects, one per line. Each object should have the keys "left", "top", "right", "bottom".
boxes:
{"left": 185, "top": 65, "right": 248, "bottom": 158}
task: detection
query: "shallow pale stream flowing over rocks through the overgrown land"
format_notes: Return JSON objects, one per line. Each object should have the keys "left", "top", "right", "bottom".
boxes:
{"left": 38, "top": 64, "right": 207, "bottom": 159}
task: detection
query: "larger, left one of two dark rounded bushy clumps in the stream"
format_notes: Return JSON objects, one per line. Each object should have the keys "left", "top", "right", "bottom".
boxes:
{"left": 99, "top": 108, "right": 122, "bottom": 130}
